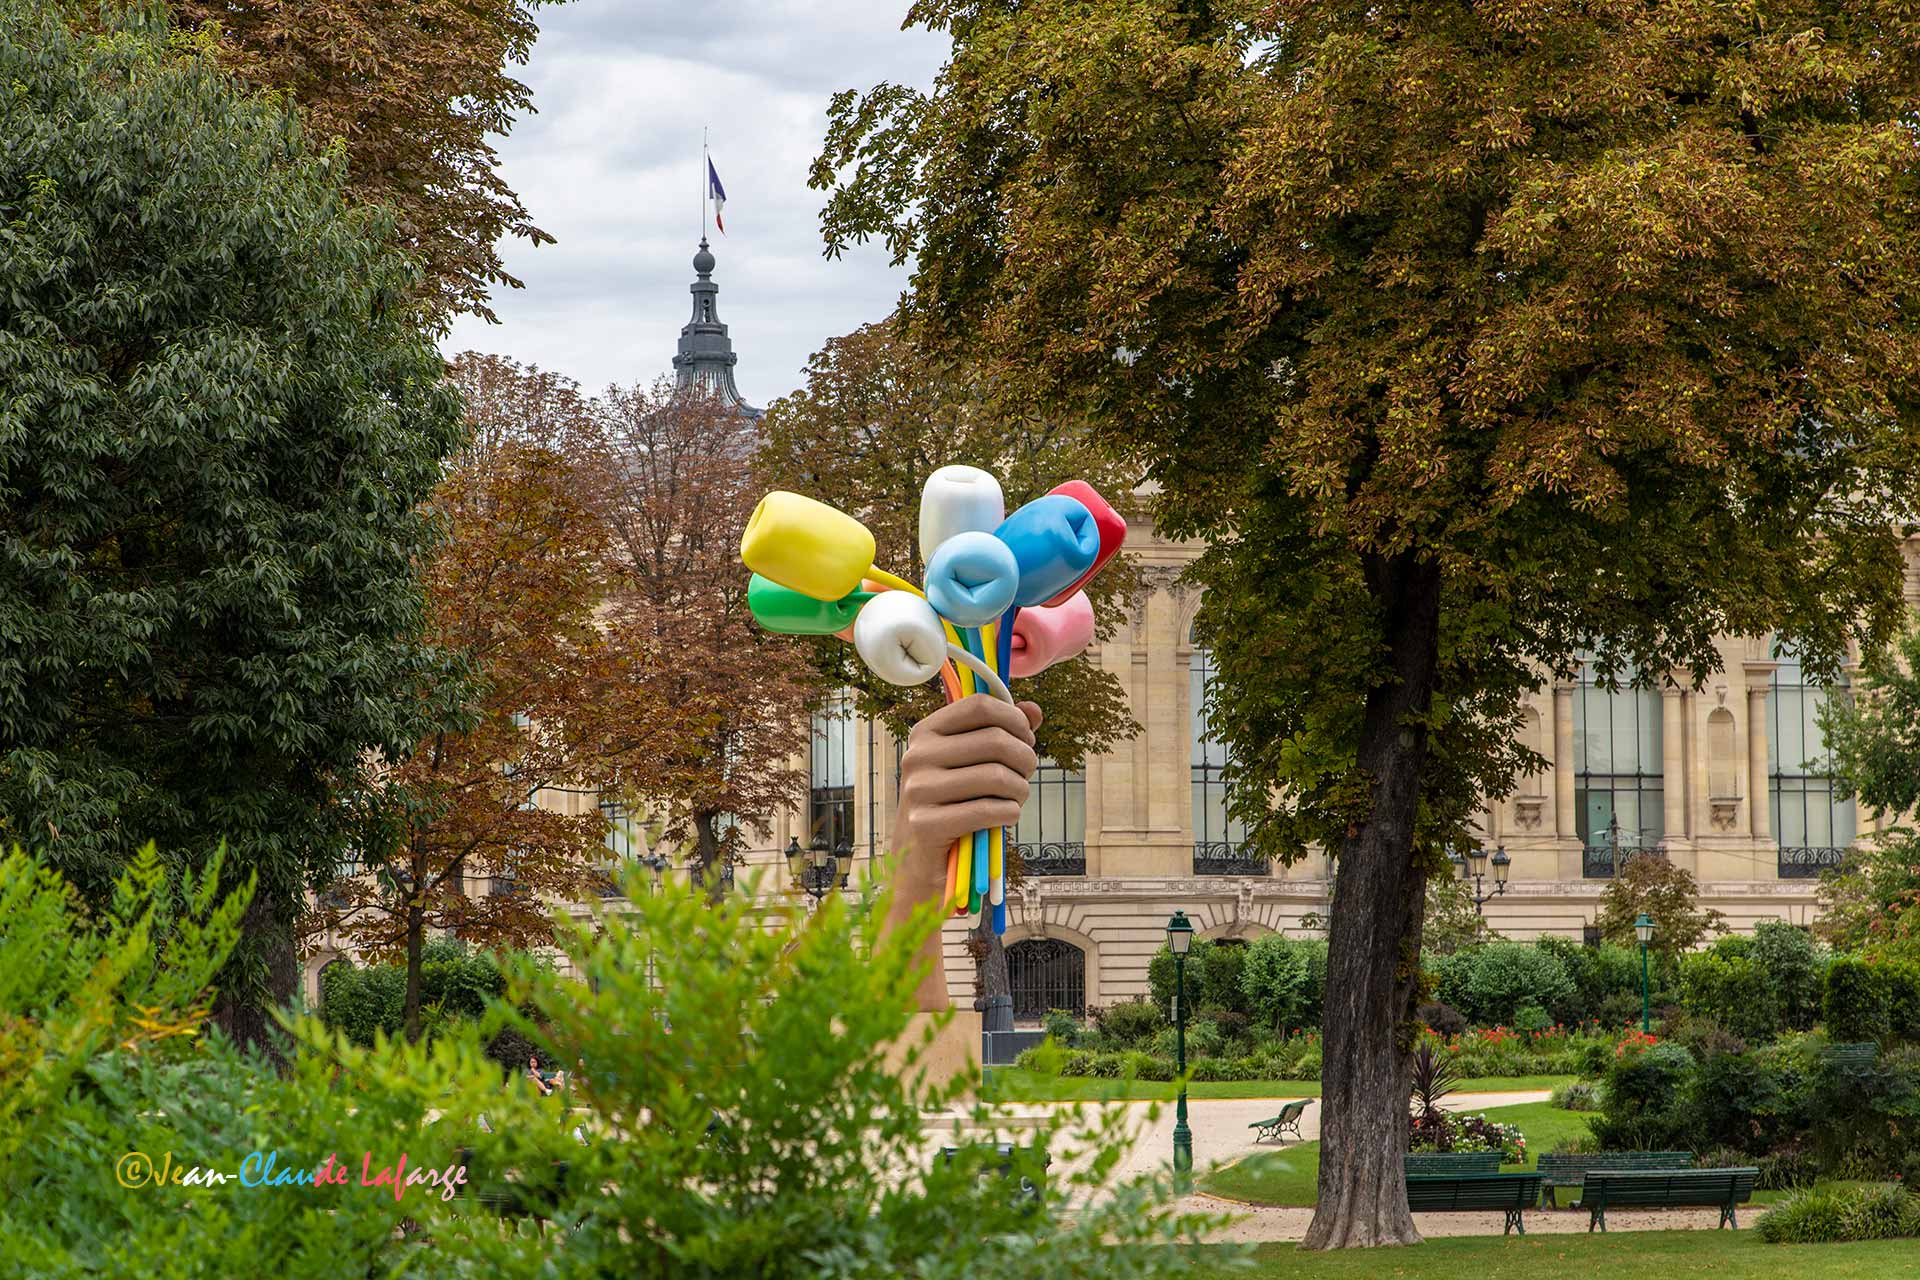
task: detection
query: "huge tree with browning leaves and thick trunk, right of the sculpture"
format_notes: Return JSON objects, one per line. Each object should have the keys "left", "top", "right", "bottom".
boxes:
{"left": 814, "top": 0, "right": 1920, "bottom": 1249}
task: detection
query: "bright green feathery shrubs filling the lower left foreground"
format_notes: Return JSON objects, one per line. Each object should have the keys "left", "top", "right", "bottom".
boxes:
{"left": 0, "top": 854, "right": 1244, "bottom": 1280}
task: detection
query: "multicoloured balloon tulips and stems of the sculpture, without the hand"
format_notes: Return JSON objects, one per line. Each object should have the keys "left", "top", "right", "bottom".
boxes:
{"left": 739, "top": 466, "right": 1127, "bottom": 935}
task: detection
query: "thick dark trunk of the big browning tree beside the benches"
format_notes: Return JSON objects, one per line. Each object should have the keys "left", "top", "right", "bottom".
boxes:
{"left": 1302, "top": 555, "right": 1440, "bottom": 1249}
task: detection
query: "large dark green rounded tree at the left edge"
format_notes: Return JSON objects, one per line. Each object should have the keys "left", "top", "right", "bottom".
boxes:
{"left": 0, "top": 4, "right": 461, "bottom": 1040}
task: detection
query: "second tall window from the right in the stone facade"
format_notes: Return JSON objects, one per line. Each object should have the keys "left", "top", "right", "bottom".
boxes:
{"left": 1572, "top": 662, "right": 1667, "bottom": 875}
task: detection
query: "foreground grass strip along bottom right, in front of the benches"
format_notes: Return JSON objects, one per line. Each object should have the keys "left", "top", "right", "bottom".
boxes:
{"left": 1190, "top": 1230, "right": 1920, "bottom": 1280}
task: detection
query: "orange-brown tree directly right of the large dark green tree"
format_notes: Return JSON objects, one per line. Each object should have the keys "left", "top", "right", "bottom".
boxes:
{"left": 323, "top": 355, "right": 680, "bottom": 1036}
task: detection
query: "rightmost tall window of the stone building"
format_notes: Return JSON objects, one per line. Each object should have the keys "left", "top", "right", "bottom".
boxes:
{"left": 1766, "top": 645, "right": 1855, "bottom": 879}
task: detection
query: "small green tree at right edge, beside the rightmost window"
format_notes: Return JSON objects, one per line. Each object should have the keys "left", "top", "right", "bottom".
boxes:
{"left": 1818, "top": 618, "right": 1920, "bottom": 961}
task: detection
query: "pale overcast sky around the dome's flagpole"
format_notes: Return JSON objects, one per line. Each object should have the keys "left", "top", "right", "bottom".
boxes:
{"left": 445, "top": 0, "right": 947, "bottom": 407}
